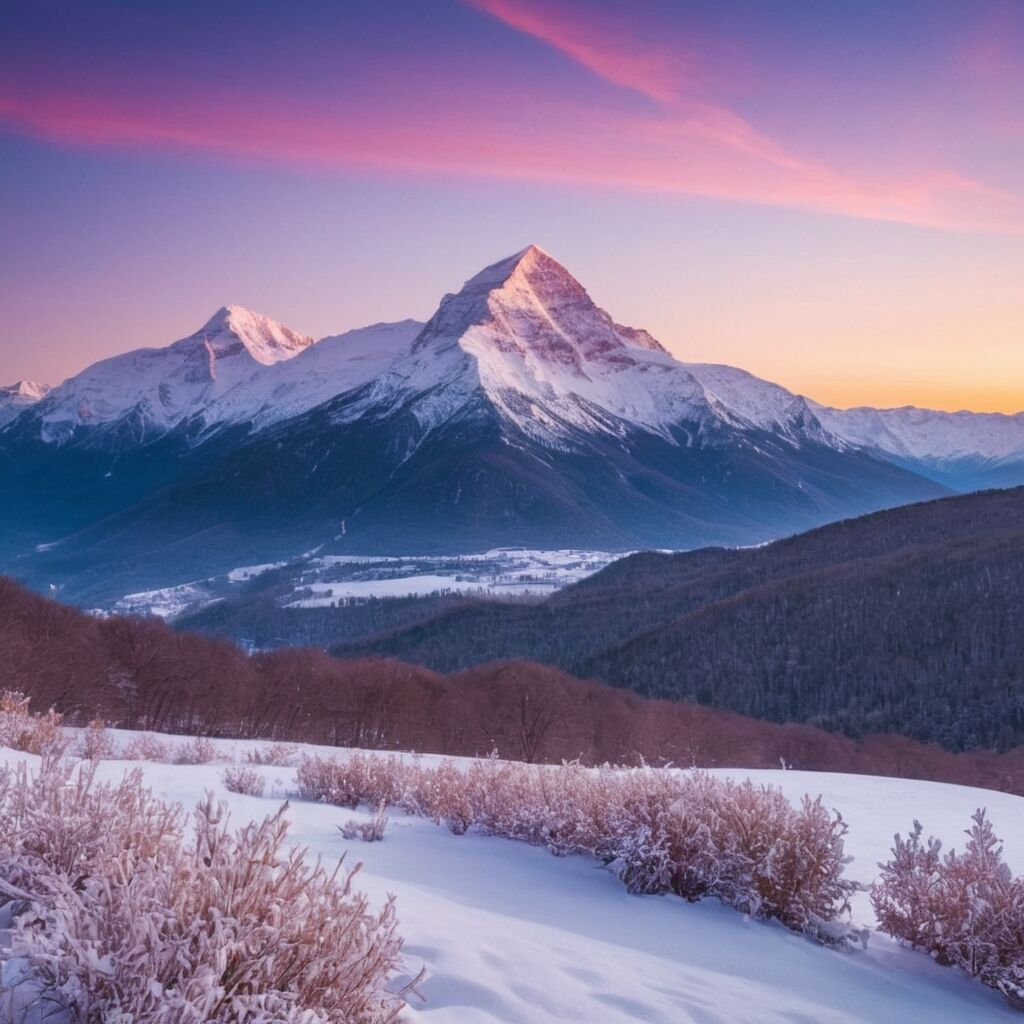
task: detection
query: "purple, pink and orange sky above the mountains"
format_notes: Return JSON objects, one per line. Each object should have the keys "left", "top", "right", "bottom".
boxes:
{"left": 0, "top": 0, "right": 1024, "bottom": 412}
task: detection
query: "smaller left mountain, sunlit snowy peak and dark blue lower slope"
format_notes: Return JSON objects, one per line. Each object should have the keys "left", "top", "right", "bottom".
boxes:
{"left": 0, "top": 306, "right": 422, "bottom": 569}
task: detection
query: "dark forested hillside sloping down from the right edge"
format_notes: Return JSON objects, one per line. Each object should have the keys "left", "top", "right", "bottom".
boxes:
{"left": 334, "top": 488, "right": 1024, "bottom": 751}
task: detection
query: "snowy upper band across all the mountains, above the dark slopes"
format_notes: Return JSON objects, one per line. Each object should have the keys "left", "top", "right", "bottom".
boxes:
{"left": 0, "top": 246, "right": 1024, "bottom": 468}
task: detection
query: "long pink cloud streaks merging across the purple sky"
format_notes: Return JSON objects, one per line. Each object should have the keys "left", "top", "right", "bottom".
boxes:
{"left": 0, "top": 7, "right": 1024, "bottom": 233}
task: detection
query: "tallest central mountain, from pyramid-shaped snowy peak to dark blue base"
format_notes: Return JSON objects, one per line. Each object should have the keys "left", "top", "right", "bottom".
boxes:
{"left": 2, "top": 246, "right": 944, "bottom": 601}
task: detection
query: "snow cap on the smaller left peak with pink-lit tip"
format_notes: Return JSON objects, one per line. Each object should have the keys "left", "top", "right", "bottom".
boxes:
{"left": 27, "top": 306, "right": 312, "bottom": 441}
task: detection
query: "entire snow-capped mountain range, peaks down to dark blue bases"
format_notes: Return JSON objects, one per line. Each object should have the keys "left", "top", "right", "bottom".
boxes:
{"left": 0, "top": 246, "right": 1024, "bottom": 604}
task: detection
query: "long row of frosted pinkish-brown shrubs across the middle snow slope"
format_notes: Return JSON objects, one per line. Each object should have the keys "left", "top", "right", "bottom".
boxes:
{"left": 298, "top": 754, "right": 863, "bottom": 945}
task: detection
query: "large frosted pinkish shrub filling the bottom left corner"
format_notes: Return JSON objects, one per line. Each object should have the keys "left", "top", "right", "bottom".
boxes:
{"left": 0, "top": 759, "right": 403, "bottom": 1024}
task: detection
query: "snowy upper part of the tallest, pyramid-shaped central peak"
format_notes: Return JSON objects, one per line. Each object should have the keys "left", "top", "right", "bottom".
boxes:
{"left": 346, "top": 246, "right": 839, "bottom": 446}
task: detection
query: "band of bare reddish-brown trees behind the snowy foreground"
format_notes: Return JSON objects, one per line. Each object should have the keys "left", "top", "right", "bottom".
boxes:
{"left": 6, "top": 578, "right": 1024, "bottom": 794}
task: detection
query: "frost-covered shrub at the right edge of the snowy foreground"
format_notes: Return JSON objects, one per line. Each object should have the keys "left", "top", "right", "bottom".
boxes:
{"left": 871, "top": 810, "right": 1024, "bottom": 1010}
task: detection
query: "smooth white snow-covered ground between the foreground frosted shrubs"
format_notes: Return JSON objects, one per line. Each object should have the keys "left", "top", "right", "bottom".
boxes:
{"left": 0, "top": 741, "right": 1024, "bottom": 1024}
